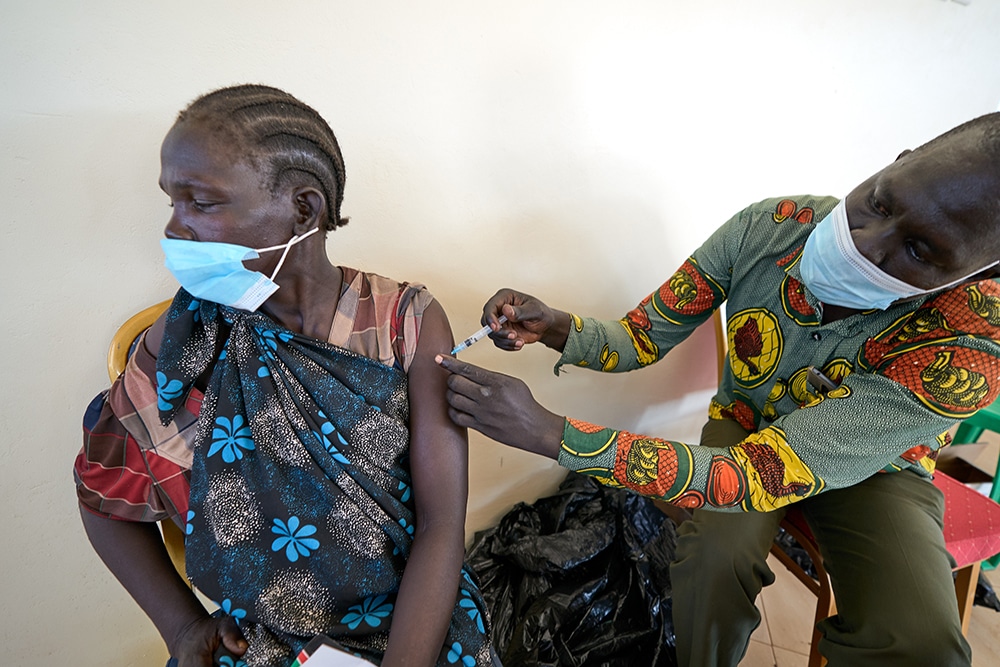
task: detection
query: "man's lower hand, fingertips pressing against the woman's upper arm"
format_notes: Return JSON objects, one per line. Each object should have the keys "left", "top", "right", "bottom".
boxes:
{"left": 435, "top": 354, "right": 563, "bottom": 459}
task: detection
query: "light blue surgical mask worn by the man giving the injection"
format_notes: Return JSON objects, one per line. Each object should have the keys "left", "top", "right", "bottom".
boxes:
{"left": 799, "top": 200, "right": 1000, "bottom": 310}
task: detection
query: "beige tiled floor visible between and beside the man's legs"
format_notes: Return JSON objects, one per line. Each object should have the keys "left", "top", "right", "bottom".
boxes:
{"left": 740, "top": 556, "right": 1000, "bottom": 667}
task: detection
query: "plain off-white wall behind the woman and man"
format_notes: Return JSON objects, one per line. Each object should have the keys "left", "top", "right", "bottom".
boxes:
{"left": 0, "top": 0, "right": 1000, "bottom": 667}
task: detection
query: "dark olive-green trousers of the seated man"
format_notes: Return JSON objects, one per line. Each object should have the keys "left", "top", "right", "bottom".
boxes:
{"left": 670, "top": 421, "right": 971, "bottom": 667}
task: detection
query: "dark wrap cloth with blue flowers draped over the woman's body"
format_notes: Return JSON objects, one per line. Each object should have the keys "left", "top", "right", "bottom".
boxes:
{"left": 78, "top": 270, "right": 492, "bottom": 667}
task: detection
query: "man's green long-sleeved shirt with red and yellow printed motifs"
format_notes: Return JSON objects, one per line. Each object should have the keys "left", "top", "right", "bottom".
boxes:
{"left": 556, "top": 196, "right": 1000, "bottom": 511}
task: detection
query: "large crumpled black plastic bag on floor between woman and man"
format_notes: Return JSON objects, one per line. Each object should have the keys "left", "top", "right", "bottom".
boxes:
{"left": 467, "top": 473, "right": 677, "bottom": 667}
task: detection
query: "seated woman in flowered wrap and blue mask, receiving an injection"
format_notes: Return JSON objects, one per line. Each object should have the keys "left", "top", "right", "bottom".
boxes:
{"left": 75, "top": 86, "right": 493, "bottom": 667}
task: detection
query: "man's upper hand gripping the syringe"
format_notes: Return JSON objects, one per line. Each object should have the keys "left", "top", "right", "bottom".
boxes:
{"left": 482, "top": 289, "right": 570, "bottom": 352}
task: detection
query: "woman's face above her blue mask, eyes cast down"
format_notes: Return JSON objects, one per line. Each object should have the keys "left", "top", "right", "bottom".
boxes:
{"left": 160, "top": 121, "right": 296, "bottom": 273}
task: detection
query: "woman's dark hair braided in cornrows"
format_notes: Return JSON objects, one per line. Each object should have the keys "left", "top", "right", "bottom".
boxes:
{"left": 177, "top": 85, "right": 347, "bottom": 230}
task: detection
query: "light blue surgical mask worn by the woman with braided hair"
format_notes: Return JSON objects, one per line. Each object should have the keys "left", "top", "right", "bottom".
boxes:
{"left": 160, "top": 227, "right": 319, "bottom": 312}
